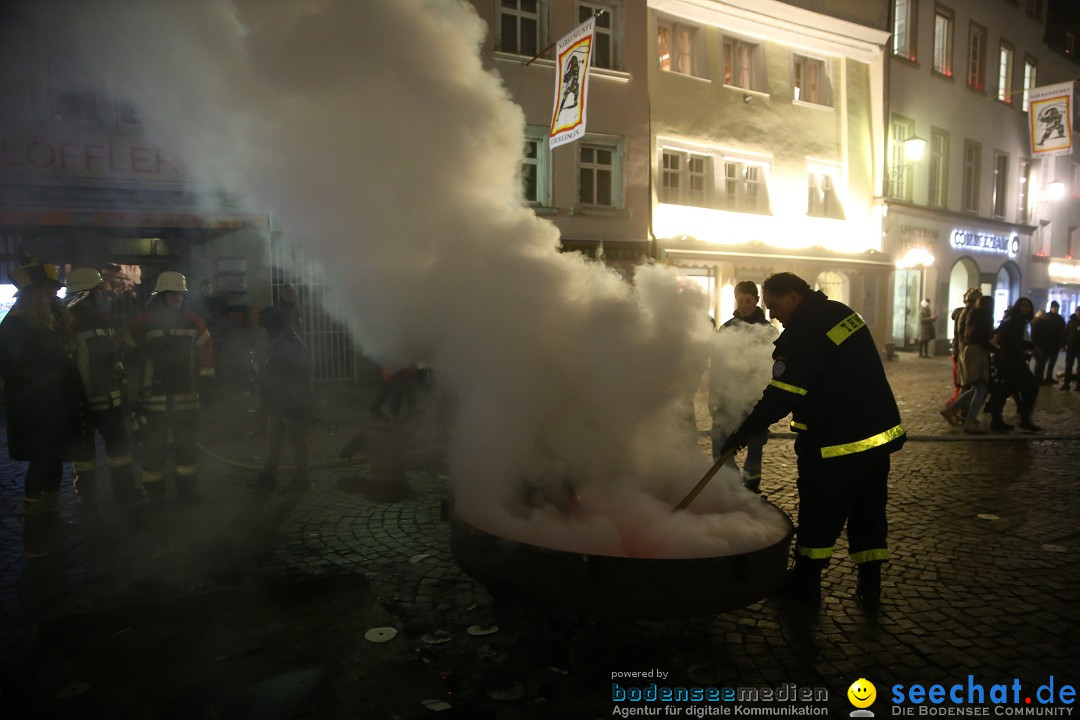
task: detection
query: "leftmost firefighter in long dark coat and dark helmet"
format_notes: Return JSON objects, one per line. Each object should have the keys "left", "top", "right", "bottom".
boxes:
{"left": 0, "top": 259, "right": 83, "bottom": 551}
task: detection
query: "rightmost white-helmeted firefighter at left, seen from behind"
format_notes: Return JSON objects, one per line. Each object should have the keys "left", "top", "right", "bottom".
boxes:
{"left": 124, "top": 270, "right": 214, "bottom": 504}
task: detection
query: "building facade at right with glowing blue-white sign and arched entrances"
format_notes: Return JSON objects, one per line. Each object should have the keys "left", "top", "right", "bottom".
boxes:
{"left": 883, "top": 0, "right": 1080, "bottom": 353}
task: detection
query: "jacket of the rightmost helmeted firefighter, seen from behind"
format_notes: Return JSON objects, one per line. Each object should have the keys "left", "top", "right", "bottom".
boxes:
{"left": 124, "top": 302, "right": 214, "bottom": 412}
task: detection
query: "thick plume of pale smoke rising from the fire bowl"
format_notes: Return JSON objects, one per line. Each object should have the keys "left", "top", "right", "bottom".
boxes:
{"left": 12, "top": 0, "right": 784, "bottom": 556}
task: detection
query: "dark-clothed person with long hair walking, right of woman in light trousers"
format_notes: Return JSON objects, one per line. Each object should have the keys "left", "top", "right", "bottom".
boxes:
{"left": 986, "top": 298, "right": 1042, "bottom": 433}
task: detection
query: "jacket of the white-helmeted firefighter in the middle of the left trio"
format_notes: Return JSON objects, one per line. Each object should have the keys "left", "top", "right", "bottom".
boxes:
{"left": 71, "top": 300, "right": 124, "bottom": 412}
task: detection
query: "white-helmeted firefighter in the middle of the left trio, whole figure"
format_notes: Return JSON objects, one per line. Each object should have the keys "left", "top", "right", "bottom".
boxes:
{"left": 64, "top": 268, "right": 140, "bottom": 508}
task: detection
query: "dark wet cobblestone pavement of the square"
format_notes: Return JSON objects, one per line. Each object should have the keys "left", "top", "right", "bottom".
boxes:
{"left": 0, "top": 353, "right": 1080, "bottom": 720}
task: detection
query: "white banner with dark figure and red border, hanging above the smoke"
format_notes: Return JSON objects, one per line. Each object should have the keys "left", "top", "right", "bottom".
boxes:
{"left": 549, "top": 16, "right": 596, "bottom": 148}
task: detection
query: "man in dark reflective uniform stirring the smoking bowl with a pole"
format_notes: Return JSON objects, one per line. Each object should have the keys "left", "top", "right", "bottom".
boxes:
{"left": 725, "top": 272, "right": 906, "bottom": 608}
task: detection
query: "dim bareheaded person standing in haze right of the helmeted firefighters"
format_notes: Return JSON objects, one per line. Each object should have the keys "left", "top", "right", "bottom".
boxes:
{"left": 253, "top": 308, "right": 315, "bottom": 491}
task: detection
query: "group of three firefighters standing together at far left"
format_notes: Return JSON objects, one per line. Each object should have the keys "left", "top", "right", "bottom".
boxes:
{"left": 0, "top": 259, "right": 214, "bottom": 544}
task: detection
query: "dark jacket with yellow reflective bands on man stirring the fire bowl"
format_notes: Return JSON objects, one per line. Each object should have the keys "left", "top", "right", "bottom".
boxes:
{"left": 737, "top": 291, "right": 906, "bottom": 461}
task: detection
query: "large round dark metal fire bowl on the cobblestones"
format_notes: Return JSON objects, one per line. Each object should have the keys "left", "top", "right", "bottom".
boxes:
{"left": 449, "top": 499, "right": 795, "bottom": 620}
